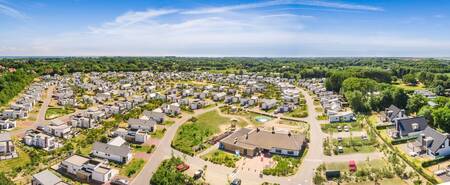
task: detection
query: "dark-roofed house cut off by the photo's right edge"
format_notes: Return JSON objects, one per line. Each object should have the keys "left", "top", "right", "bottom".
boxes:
{"left": 416, "top": 127, "right": 450, "bottom": 157}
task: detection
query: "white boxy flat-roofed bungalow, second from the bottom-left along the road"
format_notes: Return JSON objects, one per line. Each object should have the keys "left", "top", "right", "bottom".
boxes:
{"left": 58, "top": 155, "right": 118, "bottom": 183}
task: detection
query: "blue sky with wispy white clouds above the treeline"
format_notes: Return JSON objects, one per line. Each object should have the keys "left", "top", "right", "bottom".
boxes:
{"left": 0, "top": 0, "right": 450, "bottom": 57}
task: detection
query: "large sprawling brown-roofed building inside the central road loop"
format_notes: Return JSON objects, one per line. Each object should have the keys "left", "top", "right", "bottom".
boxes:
{"left": 219, "top": 128, "right": 307, "bottom": 156}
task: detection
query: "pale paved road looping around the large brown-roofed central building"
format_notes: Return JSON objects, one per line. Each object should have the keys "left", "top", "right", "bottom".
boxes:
{"left": 131, "top": 87, "right": 382, "bottom": 185}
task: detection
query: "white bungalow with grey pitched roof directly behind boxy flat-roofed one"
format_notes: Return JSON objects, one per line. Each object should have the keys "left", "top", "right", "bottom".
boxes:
{"left": 92, "top": 137, "right": 133, "bottom": 163}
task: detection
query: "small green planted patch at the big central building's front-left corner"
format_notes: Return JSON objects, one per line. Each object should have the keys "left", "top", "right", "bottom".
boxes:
{"left": 201, "top": 149, "right": 239, "bottom": 168}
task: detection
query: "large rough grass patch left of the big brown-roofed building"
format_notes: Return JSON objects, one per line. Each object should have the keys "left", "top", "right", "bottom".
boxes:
{"left": 172, "top": 111, "right": 231, "bottom": 155}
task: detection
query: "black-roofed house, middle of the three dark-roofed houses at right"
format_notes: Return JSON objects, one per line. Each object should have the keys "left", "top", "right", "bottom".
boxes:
{"left": 393, "top": 117, "right": 428, "bottom": 137}
